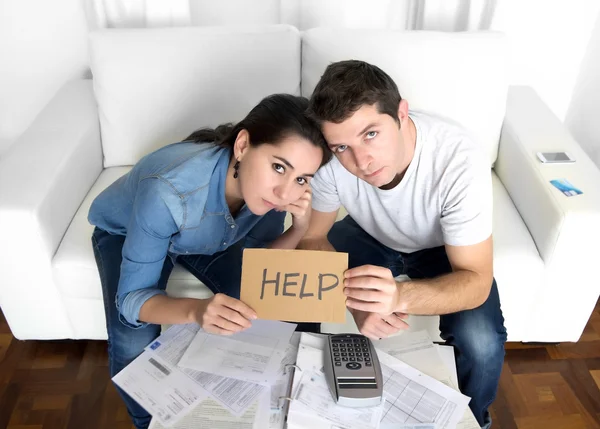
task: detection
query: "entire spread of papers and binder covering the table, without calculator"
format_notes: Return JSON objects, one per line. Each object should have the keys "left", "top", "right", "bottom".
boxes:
{"left": 114, "top": 321, "right": 479, "bottom": 429}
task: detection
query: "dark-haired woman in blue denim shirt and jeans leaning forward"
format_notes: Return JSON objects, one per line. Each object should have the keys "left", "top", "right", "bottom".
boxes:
{"left": 88, "top": 94, "right": 331, "bottom": 429}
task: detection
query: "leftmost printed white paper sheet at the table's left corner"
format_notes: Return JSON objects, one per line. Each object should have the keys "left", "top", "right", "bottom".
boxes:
{"left": 113, "top": 351, "right": 208, "bottom": 426}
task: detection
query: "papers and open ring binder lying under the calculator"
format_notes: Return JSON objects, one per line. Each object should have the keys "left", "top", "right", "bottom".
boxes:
{"left": 287, "top": 332, "right": 478, "bottom": 429}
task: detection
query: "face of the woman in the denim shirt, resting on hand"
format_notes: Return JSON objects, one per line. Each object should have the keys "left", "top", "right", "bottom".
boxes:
{"left": 237, "top": 131, "right": 323, "bottom": 215}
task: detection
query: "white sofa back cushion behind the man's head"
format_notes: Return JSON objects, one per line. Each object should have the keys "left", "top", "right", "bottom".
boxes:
{"left": 302, "top": 28, "right": 508, "bottom": 165}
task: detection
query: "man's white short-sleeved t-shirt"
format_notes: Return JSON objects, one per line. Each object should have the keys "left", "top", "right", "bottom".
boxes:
{"left": 312, "top": 111, "right": 492, "bottom": 253}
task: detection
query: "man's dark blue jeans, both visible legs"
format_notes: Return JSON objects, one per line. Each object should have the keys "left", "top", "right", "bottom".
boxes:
{"left": 328, "top": 216, "right": 506, "bottom": 427}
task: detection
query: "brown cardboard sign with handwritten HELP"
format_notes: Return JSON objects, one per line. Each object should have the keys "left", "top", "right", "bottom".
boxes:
{"left": 240, "top": 249, "right": 348, "bottom": 323}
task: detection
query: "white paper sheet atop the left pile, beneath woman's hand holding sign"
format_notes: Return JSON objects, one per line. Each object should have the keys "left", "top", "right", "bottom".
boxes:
{"left": 178, "top": 320, "right": 296, "bottom": 386}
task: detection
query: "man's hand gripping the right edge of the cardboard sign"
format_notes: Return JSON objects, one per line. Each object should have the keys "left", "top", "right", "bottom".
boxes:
{"left": 344, "top": 265, "right": 400, "bottom": 314}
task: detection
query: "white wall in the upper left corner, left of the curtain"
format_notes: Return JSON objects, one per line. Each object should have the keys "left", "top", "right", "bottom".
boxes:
{"left": 0, "top": 0, "right": 88, "bottom": 156}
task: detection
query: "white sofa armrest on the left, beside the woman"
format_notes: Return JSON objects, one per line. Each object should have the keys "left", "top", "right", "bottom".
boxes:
{"left": 0, "top": 80, "right": 102, "bottom": 339}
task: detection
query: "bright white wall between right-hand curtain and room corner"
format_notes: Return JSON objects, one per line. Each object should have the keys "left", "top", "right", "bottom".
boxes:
{"left": 491, "top": 0, "right": 600, "bottom": 121}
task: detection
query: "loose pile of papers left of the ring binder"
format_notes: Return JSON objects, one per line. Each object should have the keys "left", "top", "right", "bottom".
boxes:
{"left": 113, "top": 321, "right": 299, "bottom": 429}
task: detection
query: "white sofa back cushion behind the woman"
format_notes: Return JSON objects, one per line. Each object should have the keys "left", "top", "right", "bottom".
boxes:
{"left": 90, "top": 25, "right": 301, "bottom": 167}
